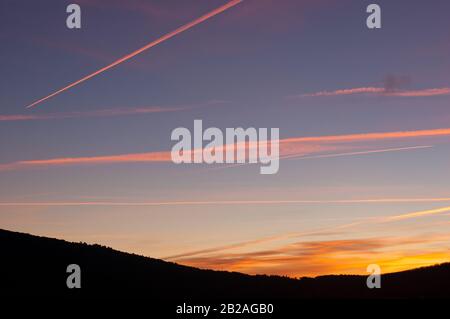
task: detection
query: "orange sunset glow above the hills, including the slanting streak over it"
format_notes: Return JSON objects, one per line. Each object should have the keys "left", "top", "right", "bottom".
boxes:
{"left": 165, "top": 206, "right": 450, "bottom": 277}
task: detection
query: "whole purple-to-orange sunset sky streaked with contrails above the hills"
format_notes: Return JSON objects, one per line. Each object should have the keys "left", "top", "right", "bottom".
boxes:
{"left": 0, "top": 0, "right": 450, "bottom": 277}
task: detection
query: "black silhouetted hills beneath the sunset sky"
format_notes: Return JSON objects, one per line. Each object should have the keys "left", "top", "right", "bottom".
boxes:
{"left": 0, "top": 230, "right": 450, "bottom": 300}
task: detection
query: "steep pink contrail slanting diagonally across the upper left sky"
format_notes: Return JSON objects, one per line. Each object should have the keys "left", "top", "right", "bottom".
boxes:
{"left": 26, "top": 0, "right": 244, "bottom": 109}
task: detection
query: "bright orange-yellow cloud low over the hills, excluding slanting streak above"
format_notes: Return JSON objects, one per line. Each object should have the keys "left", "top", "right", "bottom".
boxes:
{"left": 177, "top": 236, "right": 449, "bottom": 277}
